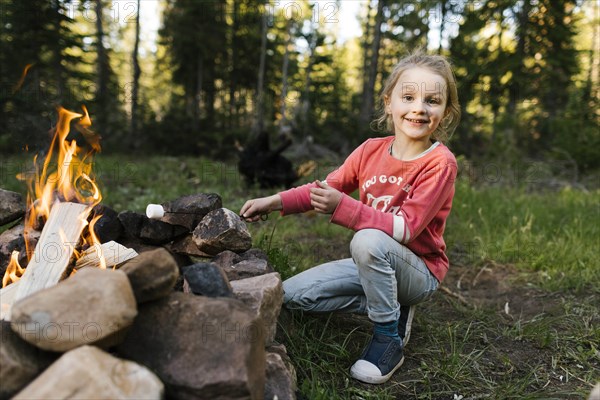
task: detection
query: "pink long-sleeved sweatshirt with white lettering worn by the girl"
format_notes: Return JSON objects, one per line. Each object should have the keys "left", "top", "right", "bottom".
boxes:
{"left": 279, "top": 136, "right": 457, "bottom": 282}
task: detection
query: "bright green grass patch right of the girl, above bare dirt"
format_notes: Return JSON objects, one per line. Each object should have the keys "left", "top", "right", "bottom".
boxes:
{"left": 445, "top": 180, "right": 600, "bottom": 292}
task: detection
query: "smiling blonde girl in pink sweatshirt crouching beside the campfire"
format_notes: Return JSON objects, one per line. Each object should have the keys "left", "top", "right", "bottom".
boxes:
{"left": 240, "top": 52, "right": 460, "bottom": 383}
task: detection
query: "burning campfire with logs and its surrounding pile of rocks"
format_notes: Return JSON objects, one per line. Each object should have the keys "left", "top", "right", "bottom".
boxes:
{"left": 0, "top": 104, "right": 295, "bottom": 399}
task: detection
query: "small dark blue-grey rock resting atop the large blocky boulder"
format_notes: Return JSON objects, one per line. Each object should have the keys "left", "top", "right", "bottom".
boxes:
{"left": 183, "top": 263, "right": 233, "bottom": 297}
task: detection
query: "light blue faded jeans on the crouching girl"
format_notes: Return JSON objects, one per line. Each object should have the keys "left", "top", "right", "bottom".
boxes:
{"left": 283, "top": 229, "right": 438, "bottom": 323}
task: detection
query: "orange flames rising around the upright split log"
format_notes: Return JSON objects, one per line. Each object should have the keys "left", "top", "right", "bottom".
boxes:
{"left": 3, "top": 104, "right": 104, "bottom": 283}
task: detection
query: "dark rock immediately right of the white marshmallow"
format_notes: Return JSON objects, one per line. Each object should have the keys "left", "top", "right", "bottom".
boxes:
{"left": 161, "top": 193, "right": 223, "bottom": 232}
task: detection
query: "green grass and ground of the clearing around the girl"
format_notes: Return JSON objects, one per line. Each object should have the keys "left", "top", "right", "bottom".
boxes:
{"left": 0, "top": 155, "right": 600, "bottom": 400}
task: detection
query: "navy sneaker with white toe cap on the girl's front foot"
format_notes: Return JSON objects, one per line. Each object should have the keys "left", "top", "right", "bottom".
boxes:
{"left": 350, "top": 333, "right": 404, "bottom": 384}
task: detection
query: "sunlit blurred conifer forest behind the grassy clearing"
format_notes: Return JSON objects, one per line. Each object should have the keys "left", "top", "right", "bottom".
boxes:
{"left": 0, "top": 0, "right": 600, "bottom": 175}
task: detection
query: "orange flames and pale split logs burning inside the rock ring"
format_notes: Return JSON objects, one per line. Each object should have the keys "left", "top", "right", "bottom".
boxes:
{"left": 1, "top": 107, "right": 137, "bottom": 320}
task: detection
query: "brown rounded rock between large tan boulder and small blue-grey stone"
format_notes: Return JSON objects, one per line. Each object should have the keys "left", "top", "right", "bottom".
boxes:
{"left": 119, "top": 248, "right": 179, "bottom": 304}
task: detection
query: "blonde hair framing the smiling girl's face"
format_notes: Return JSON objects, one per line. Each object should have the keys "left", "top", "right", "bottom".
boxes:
{"left": 373, "top": 50, "right": 460, "bottom": 142}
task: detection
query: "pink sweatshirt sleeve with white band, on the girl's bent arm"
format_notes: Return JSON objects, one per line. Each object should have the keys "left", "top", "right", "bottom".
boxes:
{"left": 331, "top": 163, "right": 456, "bottom": 243}
